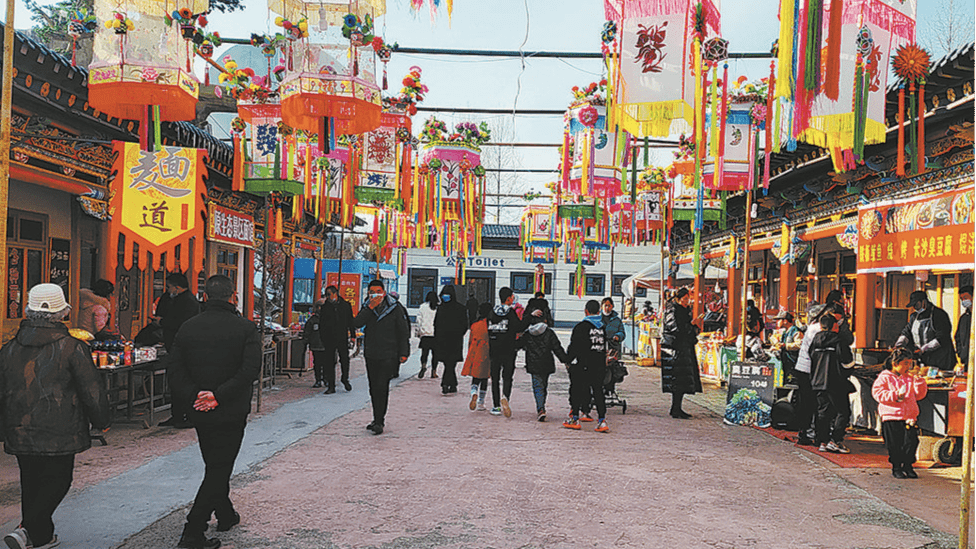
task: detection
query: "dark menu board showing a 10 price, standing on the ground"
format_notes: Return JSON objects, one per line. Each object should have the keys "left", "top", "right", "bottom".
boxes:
{"left": 725, "top": 360, "right": 776, "bottom": 428}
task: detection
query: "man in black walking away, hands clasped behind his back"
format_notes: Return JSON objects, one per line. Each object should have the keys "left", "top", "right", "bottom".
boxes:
{"left": 167, "top": 275, "right": 261, "bottom": 549}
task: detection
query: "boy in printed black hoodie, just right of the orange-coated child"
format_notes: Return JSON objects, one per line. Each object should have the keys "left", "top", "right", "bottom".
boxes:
{"left": 488, "top": 287, "right": 528, "bottom": 417}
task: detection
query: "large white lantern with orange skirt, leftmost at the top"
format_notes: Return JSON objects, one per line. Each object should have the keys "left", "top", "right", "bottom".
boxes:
{"left": 88, "top": 0, "right": 209, "bottom": 123}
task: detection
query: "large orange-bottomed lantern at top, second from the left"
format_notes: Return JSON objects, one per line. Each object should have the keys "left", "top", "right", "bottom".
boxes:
{"left": 268, "top": 0, "right": 386, "bottom": 150}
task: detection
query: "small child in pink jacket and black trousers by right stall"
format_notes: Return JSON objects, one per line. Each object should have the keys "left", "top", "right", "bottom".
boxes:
{"left": 871, "top": 348, "right": 928, "bottom": 479}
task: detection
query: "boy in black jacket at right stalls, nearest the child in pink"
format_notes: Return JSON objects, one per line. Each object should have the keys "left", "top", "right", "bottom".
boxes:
{"left": 810, "top": 313, "right": 854, "bottom": 454}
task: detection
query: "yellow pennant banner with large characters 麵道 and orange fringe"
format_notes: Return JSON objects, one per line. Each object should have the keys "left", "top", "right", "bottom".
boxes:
{"left": 109, "top": 142, "right": 206, "bottom": 270}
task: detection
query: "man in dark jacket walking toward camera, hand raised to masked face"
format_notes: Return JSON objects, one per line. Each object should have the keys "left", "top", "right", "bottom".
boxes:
{"left": 352, "top": 280, "right": 410, "bottom": 435}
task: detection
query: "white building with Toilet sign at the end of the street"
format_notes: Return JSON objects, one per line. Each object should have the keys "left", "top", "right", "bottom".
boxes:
{"left": 400, "top": 225, "right": 660, "bottom": 324}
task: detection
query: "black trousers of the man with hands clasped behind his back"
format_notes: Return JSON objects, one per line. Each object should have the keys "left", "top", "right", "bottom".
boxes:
{"left": 186, "top": 420, "right": 247, "bottom": 535}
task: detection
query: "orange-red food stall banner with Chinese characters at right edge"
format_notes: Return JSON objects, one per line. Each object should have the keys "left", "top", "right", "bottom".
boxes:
{"left": 857, "top": 187, "right": 976, "bottom": 274}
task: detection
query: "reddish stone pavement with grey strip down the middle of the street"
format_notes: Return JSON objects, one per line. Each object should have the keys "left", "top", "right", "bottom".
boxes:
{"left": 9, "top": 332, "right": 976, "bottom": 548}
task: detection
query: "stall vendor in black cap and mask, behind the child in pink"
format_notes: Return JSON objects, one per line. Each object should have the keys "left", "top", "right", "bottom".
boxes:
{"left": 895, "top": 291, "right": 956, "bottom": 370}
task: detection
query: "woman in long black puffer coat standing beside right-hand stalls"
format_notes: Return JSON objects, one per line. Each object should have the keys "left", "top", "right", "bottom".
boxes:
{"left": 661, "top": 288, "right": 702, "bottom": 419}
